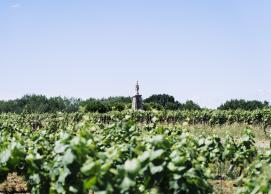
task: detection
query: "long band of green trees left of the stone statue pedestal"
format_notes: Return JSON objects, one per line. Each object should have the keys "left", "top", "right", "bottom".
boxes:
{"left": 0, "top": 95, "right": 131, "bottom": 113}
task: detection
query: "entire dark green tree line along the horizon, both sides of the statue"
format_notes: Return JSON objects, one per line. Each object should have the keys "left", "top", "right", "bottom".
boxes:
{"left": 0, "top": 94, "right": 270, "bottom": 113}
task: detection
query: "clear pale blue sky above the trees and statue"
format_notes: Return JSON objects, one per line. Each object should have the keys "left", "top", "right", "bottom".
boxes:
{"left": 0, "top": 0, "right": 271, "bottom": 107}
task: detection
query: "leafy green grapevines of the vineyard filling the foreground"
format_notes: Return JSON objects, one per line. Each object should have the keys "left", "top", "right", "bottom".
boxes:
{"left": 0, "top": 109, "right": 271, "bottom": 194}
